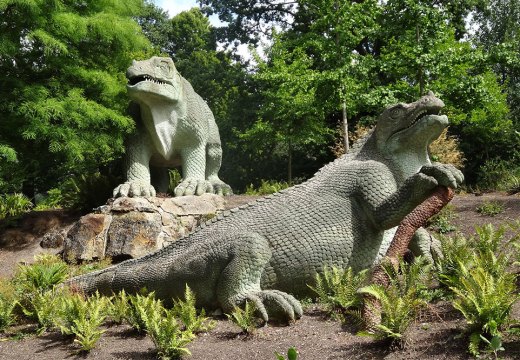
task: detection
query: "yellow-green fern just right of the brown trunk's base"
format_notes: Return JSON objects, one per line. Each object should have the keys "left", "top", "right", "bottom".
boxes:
{"left": 359, "top": 258, "right": 431, "bottom": 346}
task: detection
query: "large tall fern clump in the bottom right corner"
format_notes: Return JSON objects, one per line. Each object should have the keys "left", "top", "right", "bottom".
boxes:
{"left": 439, "top": 224, "right": 520, "bottom": 355}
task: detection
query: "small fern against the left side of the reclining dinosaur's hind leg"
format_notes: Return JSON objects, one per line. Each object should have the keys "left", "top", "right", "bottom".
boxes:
{"left": 171, "top": 285, "right": 216, "bottom": 334}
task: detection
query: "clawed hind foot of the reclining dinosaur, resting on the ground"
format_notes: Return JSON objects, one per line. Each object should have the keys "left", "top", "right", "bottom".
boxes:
{"left": 232, "top": 290, "right": 303, "bottom": 323}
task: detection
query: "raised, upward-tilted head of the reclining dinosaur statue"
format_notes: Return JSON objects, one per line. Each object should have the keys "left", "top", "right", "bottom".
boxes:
{"left": 375, "top": 91, "right": 448, "bottom": 156}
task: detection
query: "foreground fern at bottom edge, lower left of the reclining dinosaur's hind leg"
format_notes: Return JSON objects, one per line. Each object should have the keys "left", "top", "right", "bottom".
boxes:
{"left": 145, "top": 301, "right": 195, "bottom": 359}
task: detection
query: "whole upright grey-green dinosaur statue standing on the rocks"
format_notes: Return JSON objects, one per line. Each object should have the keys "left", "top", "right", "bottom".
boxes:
{"left": 114, "top": 56, "right": 231, "bottom": 197}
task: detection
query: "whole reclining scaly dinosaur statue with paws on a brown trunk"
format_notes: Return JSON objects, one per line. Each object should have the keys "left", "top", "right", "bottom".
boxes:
{"left": 71, "top": 93, "right": 463, "bottom": 321}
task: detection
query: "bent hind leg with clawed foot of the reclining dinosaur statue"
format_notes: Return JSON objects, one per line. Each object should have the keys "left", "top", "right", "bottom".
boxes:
{"left": 217, "top": 233, "right": 303, "bottom": 322}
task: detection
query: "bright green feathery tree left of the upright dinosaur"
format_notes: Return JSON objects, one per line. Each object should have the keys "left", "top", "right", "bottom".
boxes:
{"left": 0, "top": 0, "right": 151, "bottom": 196}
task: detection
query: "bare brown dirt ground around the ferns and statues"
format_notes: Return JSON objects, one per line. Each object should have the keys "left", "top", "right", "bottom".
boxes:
{"left": 0, "top": 193, "right": 520, "bottom": 360}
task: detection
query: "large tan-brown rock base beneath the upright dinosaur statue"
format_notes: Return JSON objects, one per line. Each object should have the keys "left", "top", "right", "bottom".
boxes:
{"left": 62, "top": 194, "right": 225, "bottom": 262}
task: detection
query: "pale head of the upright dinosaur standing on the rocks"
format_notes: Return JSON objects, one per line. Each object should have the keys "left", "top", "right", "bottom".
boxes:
{"left": 126, "top": 56, "right": 180, "bottom": 103}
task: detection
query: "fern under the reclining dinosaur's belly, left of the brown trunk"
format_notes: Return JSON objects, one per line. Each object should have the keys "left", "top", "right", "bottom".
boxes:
{"left": 309, "top": 267, "right": 367, "bottom": 315}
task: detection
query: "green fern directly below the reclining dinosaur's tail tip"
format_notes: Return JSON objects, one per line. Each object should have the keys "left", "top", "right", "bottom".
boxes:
{"left": 55, "top": 293, "right": 109, "bottom": 352}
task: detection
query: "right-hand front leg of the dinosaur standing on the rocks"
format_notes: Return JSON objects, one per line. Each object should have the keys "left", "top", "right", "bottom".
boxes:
{"left": 175, "top": 143, "right": 213, "bottom": 196}
